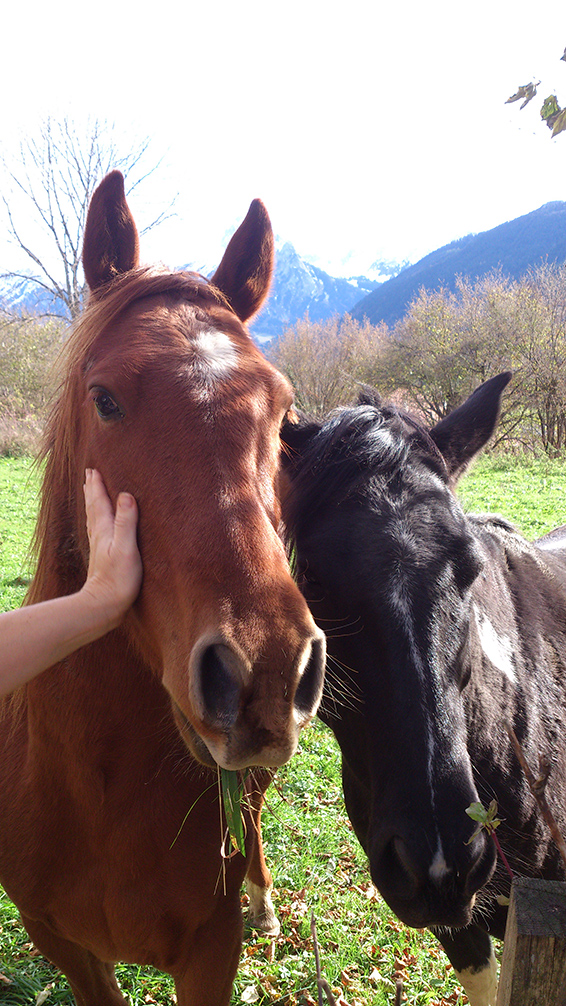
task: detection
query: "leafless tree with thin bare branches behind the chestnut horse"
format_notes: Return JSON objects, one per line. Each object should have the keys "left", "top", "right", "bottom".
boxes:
{"left": 0, "top": 118, "right": 174, "bottom": 318}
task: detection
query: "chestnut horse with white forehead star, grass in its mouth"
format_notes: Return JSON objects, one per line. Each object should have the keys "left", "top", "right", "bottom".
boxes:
{"left": 0, "top": 172, "right": 324, "bottom": 1006}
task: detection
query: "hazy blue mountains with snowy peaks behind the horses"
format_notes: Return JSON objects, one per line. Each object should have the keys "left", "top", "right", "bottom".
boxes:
{"left": 0, "top": 201, "right": 566, "bottom": 343}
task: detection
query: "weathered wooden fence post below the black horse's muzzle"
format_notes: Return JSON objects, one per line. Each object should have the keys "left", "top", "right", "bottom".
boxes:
{"left": 497, "top": 877, "right": 566, "bottom": 1006}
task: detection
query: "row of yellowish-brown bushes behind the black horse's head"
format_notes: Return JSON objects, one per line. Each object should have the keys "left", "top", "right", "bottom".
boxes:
{"left": 271, "top": 263, "right": 566, "bottom": 457}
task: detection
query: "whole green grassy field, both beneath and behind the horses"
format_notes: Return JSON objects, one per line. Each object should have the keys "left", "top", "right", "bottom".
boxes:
{"left": 0, "top": 457, "right": 566, "bottom": 1006}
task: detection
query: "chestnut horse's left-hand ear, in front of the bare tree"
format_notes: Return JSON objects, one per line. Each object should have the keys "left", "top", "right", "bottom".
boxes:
{"left": 82, "top": 171, "right": 140, "bottom": 290}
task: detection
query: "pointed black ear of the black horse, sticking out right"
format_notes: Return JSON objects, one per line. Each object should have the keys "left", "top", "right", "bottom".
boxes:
{"left": 430, "top": 371, "right": 512, "bottom": 482}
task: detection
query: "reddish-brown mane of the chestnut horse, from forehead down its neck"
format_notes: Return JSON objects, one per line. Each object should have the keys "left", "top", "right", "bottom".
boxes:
{"left": 26, "top": 266, "right": 229, "bottom": 604}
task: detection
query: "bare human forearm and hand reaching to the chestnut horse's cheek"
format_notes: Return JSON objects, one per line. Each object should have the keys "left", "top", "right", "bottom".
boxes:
{"left": 0, "top": 469, "right": 142, "bottom": 695}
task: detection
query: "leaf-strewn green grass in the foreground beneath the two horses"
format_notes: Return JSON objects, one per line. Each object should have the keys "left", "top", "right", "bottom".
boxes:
{"left": 0, "top": 722, "right": 465, "bottom": 1006}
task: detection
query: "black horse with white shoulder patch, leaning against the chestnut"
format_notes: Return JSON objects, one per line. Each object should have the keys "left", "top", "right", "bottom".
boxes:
{"left": 284, "top": 374, "right": 566, "bottom": 1006}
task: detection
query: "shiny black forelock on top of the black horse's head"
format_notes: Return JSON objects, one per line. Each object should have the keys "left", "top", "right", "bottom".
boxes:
{"left": 286, "top": 389, "right": 446, "bottom": 535}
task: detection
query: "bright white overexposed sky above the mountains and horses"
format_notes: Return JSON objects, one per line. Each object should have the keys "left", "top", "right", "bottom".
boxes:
{"left": 0, "top": 0, "right": 566, "bottom": 275}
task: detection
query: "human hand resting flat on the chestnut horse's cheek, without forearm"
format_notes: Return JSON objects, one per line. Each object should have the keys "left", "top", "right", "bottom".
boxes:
{"left": 81, "top": 469, "right": 143, "bottom": 629}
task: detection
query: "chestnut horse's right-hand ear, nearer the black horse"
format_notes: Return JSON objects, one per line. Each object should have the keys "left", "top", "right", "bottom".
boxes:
{"left": 211, "top": 199, "right": 273, "bottom": 321}
